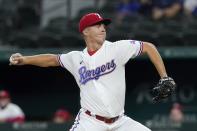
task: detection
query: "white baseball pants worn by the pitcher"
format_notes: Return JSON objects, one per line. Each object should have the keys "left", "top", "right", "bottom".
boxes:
{"left": 69, "top": 110, "right": 151, "bottom": 131}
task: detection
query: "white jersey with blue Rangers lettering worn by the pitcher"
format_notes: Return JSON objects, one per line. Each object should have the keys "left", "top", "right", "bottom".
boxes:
{"left": 58, "top": 40, "right": 143, "bottom": 117}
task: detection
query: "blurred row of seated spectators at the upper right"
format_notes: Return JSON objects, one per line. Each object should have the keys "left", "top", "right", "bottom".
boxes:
{"left": 116, "top": 0, "right": 197, "bottom": 23}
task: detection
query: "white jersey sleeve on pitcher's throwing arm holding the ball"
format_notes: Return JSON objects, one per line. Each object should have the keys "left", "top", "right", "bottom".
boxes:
{"left": 58, "top": 51, "right": 74, "bottom": 74}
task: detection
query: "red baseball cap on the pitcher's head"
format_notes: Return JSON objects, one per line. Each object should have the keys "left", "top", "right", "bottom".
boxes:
{"left": 79, "top": 13, "right": 111, "bottom": 33}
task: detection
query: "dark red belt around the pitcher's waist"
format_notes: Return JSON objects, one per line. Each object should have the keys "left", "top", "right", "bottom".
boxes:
{"left": 85, "top": 110, "right": 119, "bottom": 124}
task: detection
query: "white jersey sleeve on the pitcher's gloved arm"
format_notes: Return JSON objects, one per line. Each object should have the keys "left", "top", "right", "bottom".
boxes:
{"left": 115, "top": 40, "right": 143, "bottom": 64}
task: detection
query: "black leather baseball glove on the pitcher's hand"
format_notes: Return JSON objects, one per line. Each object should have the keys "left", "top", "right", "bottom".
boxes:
{"left": 152, "top": 77, "right": 176, "bottom": 102}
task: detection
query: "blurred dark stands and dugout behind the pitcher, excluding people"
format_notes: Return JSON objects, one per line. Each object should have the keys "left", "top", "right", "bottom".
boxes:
{"left": 0, "top": 0, "right": 197, "bottom": 131}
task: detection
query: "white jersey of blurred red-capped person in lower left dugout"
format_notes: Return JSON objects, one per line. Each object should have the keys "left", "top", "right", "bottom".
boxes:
{"left": 0, "top": 103, "right": 24, "bottom": 120}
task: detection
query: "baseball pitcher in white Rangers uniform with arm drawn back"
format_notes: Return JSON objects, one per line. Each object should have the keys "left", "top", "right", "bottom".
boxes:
{"left": 10, "top": 13, "right": 176, "bottom": 131}
